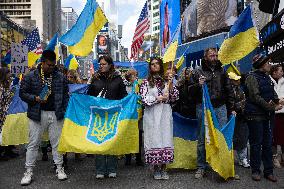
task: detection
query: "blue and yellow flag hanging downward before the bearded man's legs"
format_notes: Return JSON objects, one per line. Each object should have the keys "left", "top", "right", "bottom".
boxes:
{"left": 202, "top": 84, "right": 235, "bottom": 179}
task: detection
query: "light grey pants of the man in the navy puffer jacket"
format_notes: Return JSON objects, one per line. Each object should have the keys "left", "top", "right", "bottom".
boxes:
{"left": 25, "top": 111, "right": 63, "bottom": 168}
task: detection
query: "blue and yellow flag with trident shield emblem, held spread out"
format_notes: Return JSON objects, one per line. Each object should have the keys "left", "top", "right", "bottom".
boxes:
{"left": 58, "top": 93, "right": 139, "bottom": 155}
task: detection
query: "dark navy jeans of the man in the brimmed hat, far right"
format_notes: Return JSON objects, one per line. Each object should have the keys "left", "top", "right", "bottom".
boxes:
{"left": 247, "top": 120, "right": 273, "bottom": 176}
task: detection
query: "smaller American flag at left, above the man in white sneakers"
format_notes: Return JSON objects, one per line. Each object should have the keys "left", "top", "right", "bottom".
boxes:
{"left": 22, "top": 28, "right": 42, "bottom": 54}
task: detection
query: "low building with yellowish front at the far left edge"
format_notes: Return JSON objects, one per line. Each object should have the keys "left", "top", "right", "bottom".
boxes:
{"left": 0, "top": 11, "right": 29, "bottom": 57}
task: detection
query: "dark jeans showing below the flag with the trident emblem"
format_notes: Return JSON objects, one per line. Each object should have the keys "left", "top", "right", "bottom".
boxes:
{"left": 96, "top": 155, "right": 117, "bottom": 175}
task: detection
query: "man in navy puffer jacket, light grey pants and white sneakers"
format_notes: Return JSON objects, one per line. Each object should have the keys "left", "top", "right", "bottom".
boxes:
{"left": 20, "top": 50, "right": 69, "bottom": 185}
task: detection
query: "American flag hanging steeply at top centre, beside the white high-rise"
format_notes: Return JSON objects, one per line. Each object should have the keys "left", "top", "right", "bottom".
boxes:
{"left": 131, "top": 1, "right": 150, "bottom": 59}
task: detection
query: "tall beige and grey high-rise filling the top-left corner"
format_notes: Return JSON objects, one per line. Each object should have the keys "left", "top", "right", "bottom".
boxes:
{"left": 0, "top": 0, "right": 61, "bottom": 42}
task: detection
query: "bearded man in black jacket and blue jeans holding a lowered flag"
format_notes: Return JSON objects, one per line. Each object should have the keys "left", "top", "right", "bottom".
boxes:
{"left": 189, "top": 48, "right": 236, "bottom": 179}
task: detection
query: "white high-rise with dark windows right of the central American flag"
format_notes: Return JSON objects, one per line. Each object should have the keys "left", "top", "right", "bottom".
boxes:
{"left": 148, "top": 0, "right": 160, "bottom": 35}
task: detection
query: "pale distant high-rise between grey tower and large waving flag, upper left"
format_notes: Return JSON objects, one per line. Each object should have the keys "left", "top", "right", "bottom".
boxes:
{"left": 61, "top": 7, "right": 78, "bottom": 33}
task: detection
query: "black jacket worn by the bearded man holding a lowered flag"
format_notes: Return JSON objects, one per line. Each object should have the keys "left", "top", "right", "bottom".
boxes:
{"left": 189, "top": 59, "right": 234, "bottom": 112}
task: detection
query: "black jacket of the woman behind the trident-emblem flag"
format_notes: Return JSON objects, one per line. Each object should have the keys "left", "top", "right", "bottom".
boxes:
{"left": 88, "top": 72, "right": 127, "bottom": 100}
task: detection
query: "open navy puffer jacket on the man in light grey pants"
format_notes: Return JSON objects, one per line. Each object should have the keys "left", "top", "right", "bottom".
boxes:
{"left": 20, "top": 64, "right": 69, "bottom": 121}
